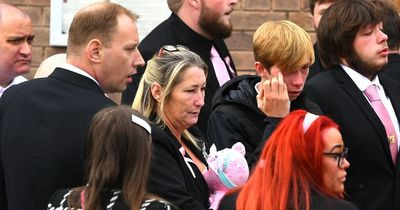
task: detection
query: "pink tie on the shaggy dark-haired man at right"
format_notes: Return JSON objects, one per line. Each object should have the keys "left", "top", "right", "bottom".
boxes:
{"left": 364, "top": 85, "right": 398, "bottom": 164}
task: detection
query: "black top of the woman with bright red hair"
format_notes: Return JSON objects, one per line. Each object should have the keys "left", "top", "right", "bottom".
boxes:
{"left": 219, "top": 192, "right": 359, "bottom": 210}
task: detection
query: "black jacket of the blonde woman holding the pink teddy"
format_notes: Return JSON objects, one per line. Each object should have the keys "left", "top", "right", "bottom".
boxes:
{"left": 147, "top": 125, "right": 209, "bottom": 210}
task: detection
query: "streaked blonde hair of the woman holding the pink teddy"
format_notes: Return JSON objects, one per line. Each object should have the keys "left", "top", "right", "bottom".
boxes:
{"left": 132, "top": 47, "right": 208, "bottom": 148}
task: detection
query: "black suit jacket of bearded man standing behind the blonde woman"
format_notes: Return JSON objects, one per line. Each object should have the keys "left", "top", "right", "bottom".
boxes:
{"left": 121, "top": 13, "right": 235, "bottom": 134}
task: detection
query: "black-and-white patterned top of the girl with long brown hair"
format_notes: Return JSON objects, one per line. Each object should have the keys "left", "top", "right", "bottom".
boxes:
{"left": 47, "top": 189, "right": 178, "bottom": 210}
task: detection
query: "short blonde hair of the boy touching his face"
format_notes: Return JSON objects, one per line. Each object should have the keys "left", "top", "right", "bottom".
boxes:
{"left": 253, "top": 20, "right": 315, "bottom": 73}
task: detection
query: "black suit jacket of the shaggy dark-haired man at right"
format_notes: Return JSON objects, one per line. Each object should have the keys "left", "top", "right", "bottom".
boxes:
{"left": 305, "top": 66, "right": 400, "bottom": 210}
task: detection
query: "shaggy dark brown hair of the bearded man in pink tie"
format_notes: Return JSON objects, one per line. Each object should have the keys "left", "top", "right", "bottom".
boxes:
{"left": 317, "top": 0, "right": 383, "bottom": 68}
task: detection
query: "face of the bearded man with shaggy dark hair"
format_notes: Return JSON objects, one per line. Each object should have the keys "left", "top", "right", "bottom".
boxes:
{"left": 345, "top": 23, "right": 389, "bottom": 78}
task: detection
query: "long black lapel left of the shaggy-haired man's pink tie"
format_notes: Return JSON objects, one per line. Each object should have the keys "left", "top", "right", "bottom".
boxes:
{"left": 332, "top": 67, "right": 394, "bottom": 168}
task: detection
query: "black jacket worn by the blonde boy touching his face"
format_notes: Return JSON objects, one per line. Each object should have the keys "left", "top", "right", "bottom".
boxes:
{"left": 207, "top": 76, "right": 322, "bottom": 167}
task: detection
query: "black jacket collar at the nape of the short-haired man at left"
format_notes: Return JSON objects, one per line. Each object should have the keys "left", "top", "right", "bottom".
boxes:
{"left": 49, "top": 68, "right": 104, "bottom": 95}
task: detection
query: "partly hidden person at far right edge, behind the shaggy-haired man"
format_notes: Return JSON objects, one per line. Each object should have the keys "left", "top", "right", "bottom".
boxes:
{"left": 372, "top": 0, "right": 400, "bottom": 83}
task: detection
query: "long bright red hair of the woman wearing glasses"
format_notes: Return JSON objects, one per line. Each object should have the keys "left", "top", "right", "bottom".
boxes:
{"left": 236, "top": 110, "right": 343, "bottom": 210}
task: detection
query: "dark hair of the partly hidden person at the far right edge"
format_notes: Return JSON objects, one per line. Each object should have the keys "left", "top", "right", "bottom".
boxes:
{"left": 372, "top": 0, "right": 400, "bottom": 50}
